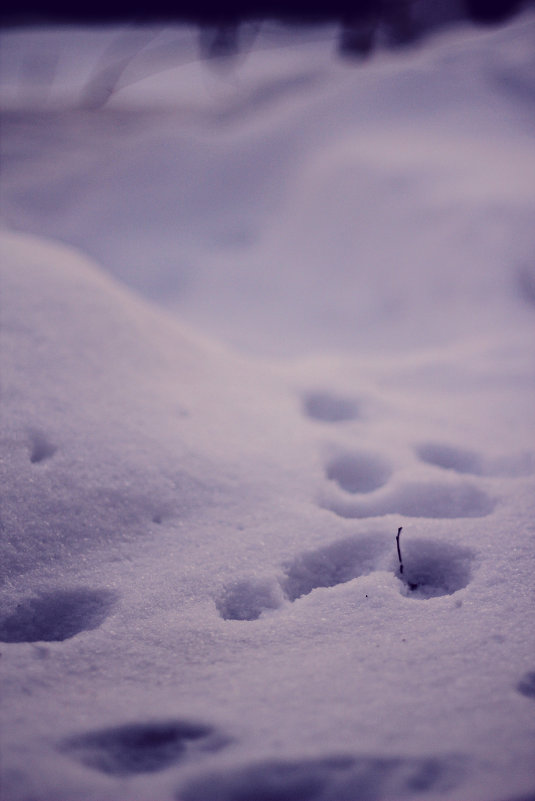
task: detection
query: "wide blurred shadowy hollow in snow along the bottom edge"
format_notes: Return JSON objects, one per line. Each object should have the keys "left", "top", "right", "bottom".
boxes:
{"left": 176, "top": 756, "right": 466, "bottom": 801}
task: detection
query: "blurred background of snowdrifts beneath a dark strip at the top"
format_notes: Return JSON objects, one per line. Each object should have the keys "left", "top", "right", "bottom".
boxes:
{"left": 0, "top": 0, "right": 535, "bottom": 356}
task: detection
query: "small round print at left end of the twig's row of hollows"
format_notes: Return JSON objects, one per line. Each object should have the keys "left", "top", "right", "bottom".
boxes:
{"left": 215, "top": 578, "right": 284, "bottom": 620}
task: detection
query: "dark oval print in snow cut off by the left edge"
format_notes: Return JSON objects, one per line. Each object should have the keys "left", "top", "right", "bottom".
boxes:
{"left": 0, "top": 587, "right": 118, "bottom": 643}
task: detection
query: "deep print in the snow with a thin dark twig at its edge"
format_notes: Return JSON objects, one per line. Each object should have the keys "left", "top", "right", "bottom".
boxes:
{"left": 396, "top": 539, "right": 475, "bottom": 599}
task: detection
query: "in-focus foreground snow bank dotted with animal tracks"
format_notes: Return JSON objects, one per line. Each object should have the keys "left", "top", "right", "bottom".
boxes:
{"left": 0, "top": 232, "right": 535, "bottom": 801}
